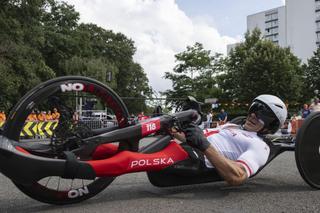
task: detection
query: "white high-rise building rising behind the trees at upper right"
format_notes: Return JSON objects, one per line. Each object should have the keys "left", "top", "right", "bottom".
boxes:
{"left": 227, "top": 0, "right": 320, "bottom": 62}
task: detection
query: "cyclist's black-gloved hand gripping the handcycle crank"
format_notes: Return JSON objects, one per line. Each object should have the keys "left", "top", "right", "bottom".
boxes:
{"left": 184, "top": 124, "right": 210, "bottom": 152}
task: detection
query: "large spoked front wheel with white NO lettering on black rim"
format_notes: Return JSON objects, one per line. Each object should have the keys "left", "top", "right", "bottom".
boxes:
{"left": 3, "top": 76, "right": 129, "bottom": 204}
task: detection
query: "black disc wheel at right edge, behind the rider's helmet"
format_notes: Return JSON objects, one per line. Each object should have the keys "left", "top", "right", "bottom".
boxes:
{"left": 295, "top": 112, "right": 320, "bottom": 189}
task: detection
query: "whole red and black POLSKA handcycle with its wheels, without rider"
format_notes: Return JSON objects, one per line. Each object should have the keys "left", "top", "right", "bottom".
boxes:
{"left": 0, "top": 76, "right": 320, "bottom": 205}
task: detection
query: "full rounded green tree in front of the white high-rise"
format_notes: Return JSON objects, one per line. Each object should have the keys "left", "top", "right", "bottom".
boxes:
{"left": 219, "top": 29, "right": 302, "bottom": 103}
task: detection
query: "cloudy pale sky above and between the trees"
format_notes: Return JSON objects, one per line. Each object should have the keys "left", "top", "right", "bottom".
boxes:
{"left": 65, "top": 0, "right": 284, "bottom": 92}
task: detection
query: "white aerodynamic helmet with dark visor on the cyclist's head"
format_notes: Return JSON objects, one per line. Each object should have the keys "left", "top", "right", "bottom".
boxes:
{"left": 249, "top": 95, "right": 287, "bottom": 133}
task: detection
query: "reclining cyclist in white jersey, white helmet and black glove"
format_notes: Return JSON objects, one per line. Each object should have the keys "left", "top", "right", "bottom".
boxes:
{"left": 177, "top": 95, "right": 287, "bottom": 185}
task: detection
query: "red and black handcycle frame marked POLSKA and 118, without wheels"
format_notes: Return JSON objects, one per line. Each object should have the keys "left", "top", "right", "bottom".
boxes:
{"left": 0, "top": 110, "right": 198, "bottom": 184}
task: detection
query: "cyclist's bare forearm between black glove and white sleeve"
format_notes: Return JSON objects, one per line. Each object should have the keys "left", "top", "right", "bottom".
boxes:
{"left": 203, "top": 145, "right": 248, "bottom": 186}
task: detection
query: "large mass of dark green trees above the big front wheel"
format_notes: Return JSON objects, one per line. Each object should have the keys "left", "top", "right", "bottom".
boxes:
{"left": 0, "top": 0, "right": 152, "bottom": 112}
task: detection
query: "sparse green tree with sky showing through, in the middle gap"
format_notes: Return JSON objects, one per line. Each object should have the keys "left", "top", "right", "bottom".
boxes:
{"left": 163, "top": 43, "right": 224, "bottom": 109}
